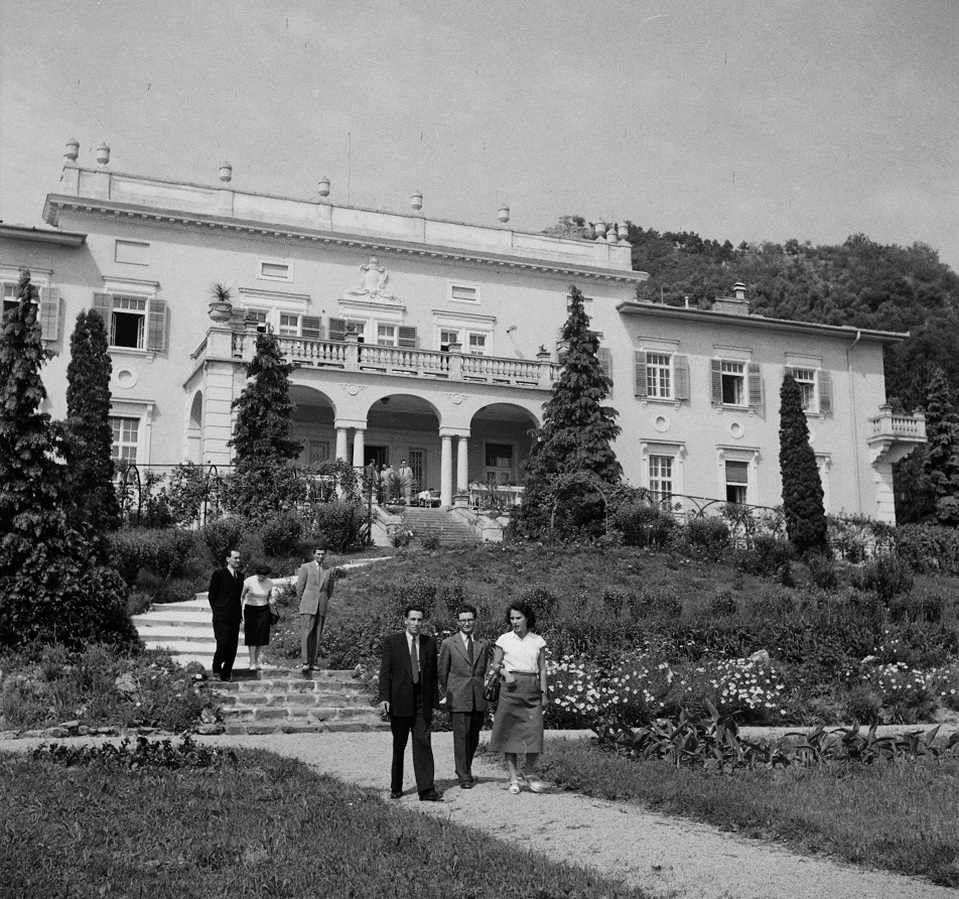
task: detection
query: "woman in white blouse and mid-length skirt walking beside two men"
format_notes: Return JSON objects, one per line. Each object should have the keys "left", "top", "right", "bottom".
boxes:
{"left": 489, "top": 602, "right": 546, "bottom": 794}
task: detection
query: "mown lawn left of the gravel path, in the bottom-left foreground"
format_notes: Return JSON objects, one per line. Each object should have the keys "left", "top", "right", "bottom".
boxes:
{"left": 0, "top": 750, "right": 643, "bottom": 899}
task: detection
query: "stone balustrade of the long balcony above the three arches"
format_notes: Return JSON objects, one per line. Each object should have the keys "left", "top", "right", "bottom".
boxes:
{"left": 191, "top": 327, "right": 560, "bottom": 390}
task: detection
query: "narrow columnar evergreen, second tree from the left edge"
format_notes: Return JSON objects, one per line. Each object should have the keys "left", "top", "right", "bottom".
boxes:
{"left": 64, "top": 309, "right": 120, "bottom": 544}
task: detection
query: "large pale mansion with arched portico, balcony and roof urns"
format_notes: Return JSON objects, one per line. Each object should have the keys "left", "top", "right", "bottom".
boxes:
{"left": 0, "top": 142, "right": 925, "bottom": 521}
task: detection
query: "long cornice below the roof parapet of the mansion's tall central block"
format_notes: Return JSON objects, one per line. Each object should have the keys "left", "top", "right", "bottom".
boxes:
{"left": 43, "top": 194, "right": 649, "bottom": 284}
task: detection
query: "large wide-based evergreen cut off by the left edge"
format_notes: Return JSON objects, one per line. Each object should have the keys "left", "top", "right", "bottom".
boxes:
{"left": 0, "top": 272, "right": 137, "bottom": 646}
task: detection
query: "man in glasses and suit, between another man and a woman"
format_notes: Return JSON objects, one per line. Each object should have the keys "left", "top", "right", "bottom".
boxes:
{"left": 438, "top": 605, "right": 489, "bottom": 790}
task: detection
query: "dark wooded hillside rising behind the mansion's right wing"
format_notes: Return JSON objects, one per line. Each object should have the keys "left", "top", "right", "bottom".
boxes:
{"left": 544, "top": 216, "right": 959, "bottom": 520}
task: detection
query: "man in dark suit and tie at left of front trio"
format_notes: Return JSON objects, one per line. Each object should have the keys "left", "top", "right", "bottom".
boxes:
{"left": 379, "top": 603, "right": 443, "bottom": 802}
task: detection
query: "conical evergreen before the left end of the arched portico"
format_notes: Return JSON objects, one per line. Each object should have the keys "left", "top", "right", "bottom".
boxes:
{"left": 228, "top": 333, "right": 302, "bottom": 520}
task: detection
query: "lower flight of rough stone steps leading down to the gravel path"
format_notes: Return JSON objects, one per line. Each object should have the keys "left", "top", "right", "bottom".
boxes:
{"left": 210, "top": 668, "right": 389, "bottom": 734}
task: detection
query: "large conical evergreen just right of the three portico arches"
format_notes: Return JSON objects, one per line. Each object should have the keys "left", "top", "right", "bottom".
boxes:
{"left": 525, "top": 285, "right": 622, "bottom": 526}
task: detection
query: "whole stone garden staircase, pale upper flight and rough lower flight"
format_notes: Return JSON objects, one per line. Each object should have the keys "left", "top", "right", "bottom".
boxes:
{"left": 133, "top": 593, "right": 389, "bottom": 734}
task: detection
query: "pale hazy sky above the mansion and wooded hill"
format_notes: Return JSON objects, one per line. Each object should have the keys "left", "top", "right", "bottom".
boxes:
{"left": 0, "top": 0, "right": 959, "bottom": 269}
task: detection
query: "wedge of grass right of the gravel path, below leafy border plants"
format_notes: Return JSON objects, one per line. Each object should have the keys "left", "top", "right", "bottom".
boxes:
{"left": 543, "top": 740, "right": 959, "bottom": 887}
